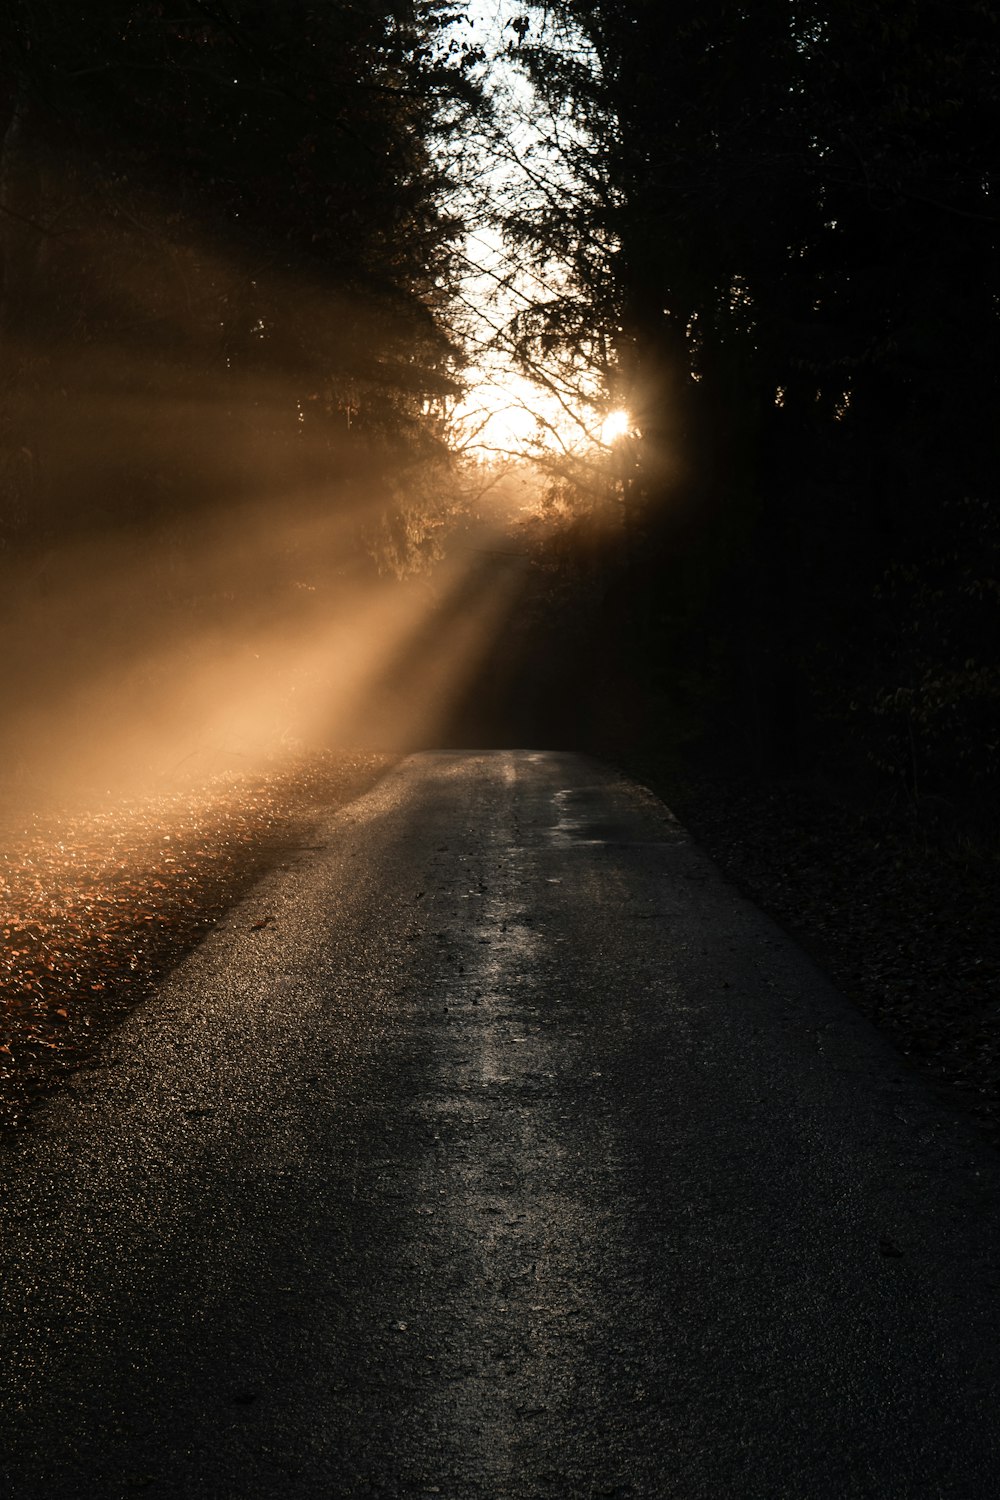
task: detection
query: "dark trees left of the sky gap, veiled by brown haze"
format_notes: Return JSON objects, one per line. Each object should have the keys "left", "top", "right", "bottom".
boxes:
{"left": 0, "top": 0, "right": 485, "bottom": 786}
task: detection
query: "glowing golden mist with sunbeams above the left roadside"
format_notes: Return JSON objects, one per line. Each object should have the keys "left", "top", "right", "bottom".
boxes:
{"left": 3, "top": 337, "right": 530, "bottom": 797}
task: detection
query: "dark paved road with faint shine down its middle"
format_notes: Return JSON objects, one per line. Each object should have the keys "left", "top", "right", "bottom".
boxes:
{"left": 0, "top": 753, "right": 1000, "bottom": 1500}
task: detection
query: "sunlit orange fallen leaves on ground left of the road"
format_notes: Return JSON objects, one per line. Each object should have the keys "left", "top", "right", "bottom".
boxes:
{"left": 0, "top": 753, "right": 391, "bottom": 1125}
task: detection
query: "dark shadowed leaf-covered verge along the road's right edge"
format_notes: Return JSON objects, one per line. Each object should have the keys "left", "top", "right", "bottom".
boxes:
{"left": 653, "top": 767, "right": 1000, "bottom": 1146}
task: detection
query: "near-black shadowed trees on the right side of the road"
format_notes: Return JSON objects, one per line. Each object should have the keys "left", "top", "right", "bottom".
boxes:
{"left": 507, "top": 0, "right": 1000, "bottom": 809}
